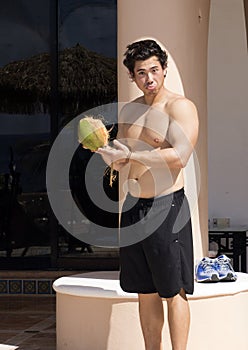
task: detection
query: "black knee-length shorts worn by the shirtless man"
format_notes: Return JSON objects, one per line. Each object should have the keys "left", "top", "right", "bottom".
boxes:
{"left": 120, "top": 189, "right": 194, "bottom": 298}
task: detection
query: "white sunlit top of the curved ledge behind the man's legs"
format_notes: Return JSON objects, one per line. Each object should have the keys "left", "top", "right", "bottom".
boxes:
{"left": 53, "top": 271, "right": 248, "bottom": 300}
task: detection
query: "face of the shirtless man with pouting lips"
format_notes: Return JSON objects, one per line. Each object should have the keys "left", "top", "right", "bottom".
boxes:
{"left": 133, "top": 56, "right": 166, "bottom": 95}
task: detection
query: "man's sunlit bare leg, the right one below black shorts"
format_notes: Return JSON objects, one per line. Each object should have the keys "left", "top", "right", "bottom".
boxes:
{"left": 166, "top": 289, "right": 190, "bottom": 350}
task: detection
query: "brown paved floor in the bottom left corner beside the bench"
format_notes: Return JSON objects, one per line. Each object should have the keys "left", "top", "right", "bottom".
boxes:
{"left": 0, "top": 295, "right": 56, "bottom": 350}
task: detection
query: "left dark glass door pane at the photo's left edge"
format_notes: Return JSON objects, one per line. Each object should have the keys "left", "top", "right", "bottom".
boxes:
{"left": 0, "top": 0, "right": 50, "bottom": 256}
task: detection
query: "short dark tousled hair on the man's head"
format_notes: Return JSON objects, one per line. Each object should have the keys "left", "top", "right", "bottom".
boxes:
{"left": 123, "top": 39, "right": 168, "bottom": 74}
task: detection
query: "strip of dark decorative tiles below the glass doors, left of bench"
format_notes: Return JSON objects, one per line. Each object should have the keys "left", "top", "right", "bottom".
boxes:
{"left": 0, "top": 279, "right": 55, "bottom": 295}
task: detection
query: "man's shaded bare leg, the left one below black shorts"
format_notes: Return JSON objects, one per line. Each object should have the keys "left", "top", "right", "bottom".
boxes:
{"left": 139, "top": 293, "right": 164, "bottom": 350}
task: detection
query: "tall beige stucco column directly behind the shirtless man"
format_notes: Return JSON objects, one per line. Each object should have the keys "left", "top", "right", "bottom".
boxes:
{"left": 118, "top": 0, "right": 210, "bottom": 259}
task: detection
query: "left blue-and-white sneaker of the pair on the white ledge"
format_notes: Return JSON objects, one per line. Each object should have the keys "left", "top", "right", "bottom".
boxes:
{"left": 195, "top": 257, "right": 220, "bottom": 282}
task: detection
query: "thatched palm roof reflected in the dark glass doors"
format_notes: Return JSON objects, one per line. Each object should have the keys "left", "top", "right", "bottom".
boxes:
{"left": 0, "top": 44, "right": 117, "bottom": 115}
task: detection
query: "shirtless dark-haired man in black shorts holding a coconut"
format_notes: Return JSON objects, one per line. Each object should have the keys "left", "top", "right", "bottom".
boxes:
{"left": 97, "top": 40, "right": 198, "bottom": 350}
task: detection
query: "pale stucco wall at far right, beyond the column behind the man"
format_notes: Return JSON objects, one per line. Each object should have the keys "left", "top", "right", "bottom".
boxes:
{"left": 208, "top": 0, "right": 248, "bottom": 225}
